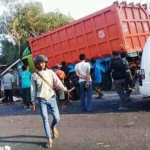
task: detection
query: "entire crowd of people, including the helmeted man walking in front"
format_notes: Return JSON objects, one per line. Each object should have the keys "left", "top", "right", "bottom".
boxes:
{"left": 1, "top": 51, "right": 140, "bottom": 148}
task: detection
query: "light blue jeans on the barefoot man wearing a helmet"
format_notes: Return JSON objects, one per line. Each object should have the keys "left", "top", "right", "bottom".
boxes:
{"left": 38, "top": 97, "right": 60, "bottom": 139}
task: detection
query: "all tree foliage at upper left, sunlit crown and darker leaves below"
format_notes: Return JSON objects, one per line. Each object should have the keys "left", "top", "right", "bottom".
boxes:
{"left": 0, "top": 0, "right": 73, "bottom": 61}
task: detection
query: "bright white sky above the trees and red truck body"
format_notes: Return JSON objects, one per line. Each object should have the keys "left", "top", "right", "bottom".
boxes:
{"left": 0, "top": 0, "right": 148, "bottom": 19}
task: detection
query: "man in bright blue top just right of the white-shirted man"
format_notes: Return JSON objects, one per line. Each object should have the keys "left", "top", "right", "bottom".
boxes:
{"left": 91, "top": 59, "right": 105, "bottom": 99}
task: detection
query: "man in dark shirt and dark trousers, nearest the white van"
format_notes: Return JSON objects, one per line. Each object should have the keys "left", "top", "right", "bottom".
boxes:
{"left": 110, "top": 51, "right": 127, "bottom": 109}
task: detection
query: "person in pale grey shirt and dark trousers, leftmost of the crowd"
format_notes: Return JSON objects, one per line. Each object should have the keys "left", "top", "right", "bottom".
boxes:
{"left": 1, "top": 69, "right": 14, "bottom": 104}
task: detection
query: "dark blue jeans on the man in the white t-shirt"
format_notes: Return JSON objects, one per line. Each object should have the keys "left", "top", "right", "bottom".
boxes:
{"left": 80, "top": 81, "right": 93, "bottom": 111}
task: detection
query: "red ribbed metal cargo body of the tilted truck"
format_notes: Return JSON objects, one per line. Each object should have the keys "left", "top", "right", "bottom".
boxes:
{"left": 28, "top": 2, "right": 150, "bottom": 67}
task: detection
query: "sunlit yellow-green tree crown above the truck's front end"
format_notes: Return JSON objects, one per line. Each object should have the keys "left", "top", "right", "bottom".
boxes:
{"left": 6, "top": 2, "right": 73, "bottom": 38}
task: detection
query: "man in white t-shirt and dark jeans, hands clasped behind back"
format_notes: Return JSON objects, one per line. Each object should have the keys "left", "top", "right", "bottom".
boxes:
{"left": 75, "top": 54, "right": 92, "bottom": 111}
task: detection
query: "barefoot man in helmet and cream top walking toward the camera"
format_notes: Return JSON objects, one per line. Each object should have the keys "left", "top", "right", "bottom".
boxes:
{"left": 31, "top": 55, "right": 70, "bottom": 148}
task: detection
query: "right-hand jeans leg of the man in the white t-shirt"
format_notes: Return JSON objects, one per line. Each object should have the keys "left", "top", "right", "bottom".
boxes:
{"left": 87, "top": 82, "right": 93, "bottom": 111}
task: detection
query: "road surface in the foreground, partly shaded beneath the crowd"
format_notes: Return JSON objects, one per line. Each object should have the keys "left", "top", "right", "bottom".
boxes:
{"left": 0, "top": 92, "right": 150, "bottom": 150}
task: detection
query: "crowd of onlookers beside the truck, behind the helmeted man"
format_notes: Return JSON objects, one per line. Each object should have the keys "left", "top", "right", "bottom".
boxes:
{"left": 1, "top": 51, "right": 140, "bottom": 111}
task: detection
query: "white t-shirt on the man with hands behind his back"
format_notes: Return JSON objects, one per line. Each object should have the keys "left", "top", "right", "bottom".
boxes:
{"left": 75, "top": 62, "right": 91, "bottom": 82}
